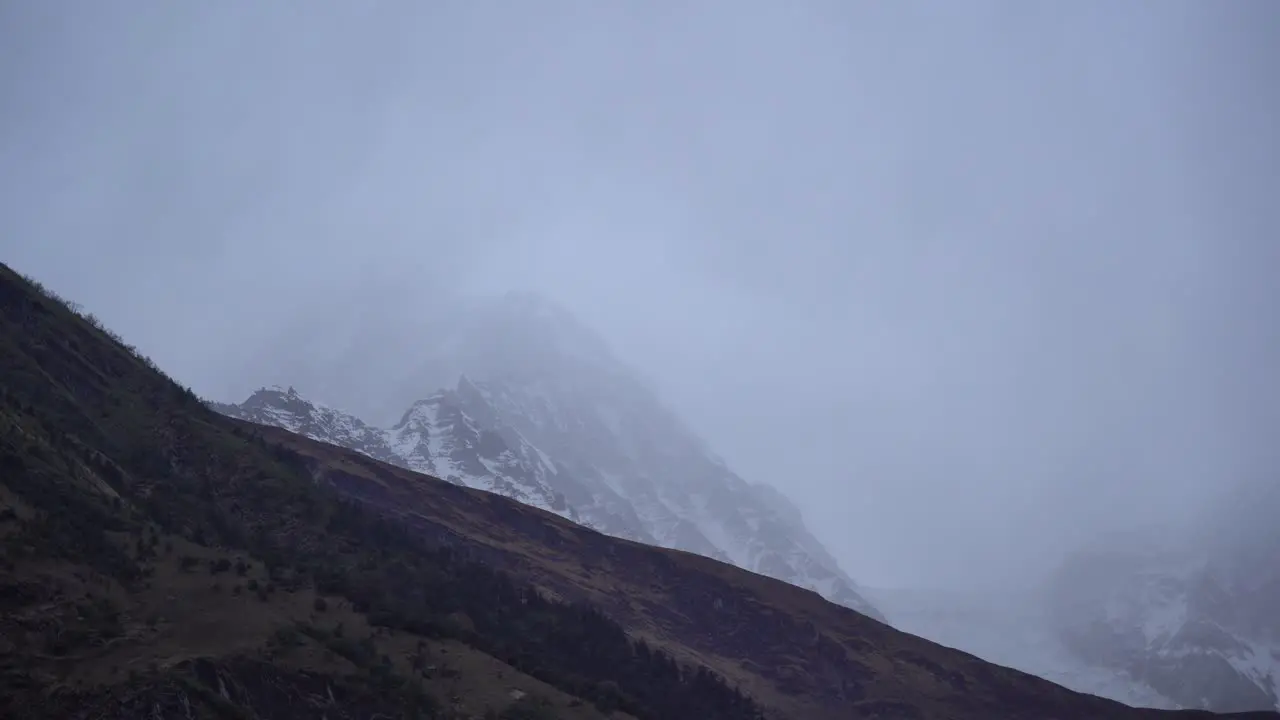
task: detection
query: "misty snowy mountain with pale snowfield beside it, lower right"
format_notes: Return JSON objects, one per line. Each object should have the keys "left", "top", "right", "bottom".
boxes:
{"left": 868, "top": 482, "right": 1280, "bottom": 712}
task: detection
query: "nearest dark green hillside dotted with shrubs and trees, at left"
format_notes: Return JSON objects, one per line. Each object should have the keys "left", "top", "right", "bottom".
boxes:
{"left": 0, "top": 268, "right": 758, "bottom": 719}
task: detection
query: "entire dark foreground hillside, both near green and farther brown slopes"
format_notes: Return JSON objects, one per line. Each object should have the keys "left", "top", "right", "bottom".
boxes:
{"left": 0, "top": 266, "right": 1280, "bottom": 720}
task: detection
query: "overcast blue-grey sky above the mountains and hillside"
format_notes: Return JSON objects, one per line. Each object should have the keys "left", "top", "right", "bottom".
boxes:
{"left": 0, "top": 0, "right": 1280, "bottom": 584}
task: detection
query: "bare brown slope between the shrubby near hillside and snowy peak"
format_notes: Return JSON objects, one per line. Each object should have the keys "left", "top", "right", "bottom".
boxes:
{"left": 252, "top": 423, "right": 1276, "bottom": 719}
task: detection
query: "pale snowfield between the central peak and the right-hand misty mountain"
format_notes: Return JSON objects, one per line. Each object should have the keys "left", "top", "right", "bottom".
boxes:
{"left": 867, "top": 589, "right": 1178, "bottom": 708}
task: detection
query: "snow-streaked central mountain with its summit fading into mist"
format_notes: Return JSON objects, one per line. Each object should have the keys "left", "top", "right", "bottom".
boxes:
{"left": 214, "top": 288, "right": 883, "bottom": 619}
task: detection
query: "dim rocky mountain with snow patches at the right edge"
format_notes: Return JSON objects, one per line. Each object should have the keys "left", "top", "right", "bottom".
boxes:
{"left": 1047, "top": 517, "right": 1280, "bottom": 711}
